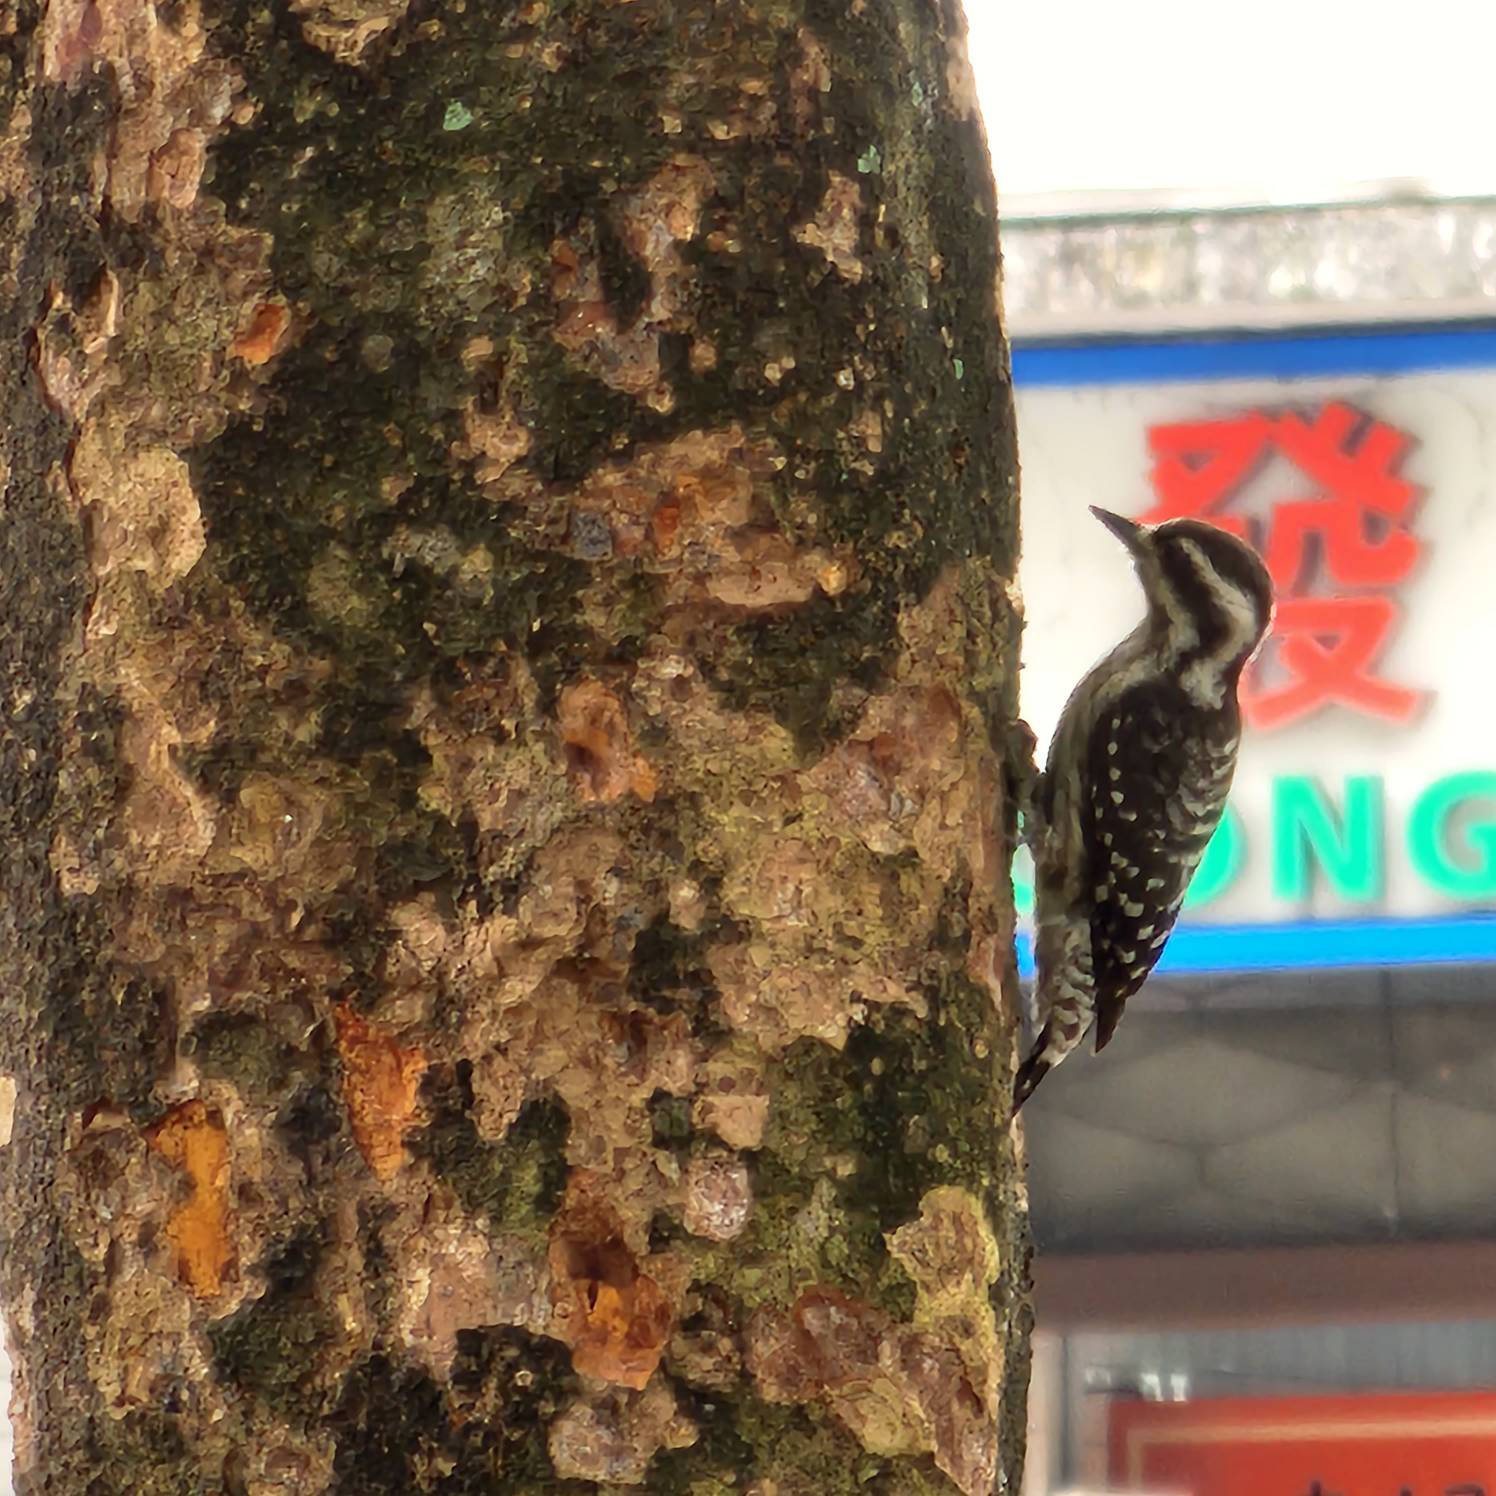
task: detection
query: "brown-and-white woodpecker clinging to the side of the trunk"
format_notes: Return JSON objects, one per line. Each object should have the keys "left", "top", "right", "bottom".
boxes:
{"left": 1013, "top": 509, "right": 1273, "bottom": 1110}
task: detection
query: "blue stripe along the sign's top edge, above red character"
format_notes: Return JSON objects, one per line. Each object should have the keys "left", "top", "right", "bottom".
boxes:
{"left": 1013, "top": 323, "right": 1496, "bottom": 389}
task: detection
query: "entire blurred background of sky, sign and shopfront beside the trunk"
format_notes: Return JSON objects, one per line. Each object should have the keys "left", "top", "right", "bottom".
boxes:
{"left": 968, "top": 0, "right": 1496, "bottom": 1496}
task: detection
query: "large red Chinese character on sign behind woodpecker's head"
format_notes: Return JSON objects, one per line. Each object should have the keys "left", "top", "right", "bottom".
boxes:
{"left": 1141, "top": 401, "right": 1421, "bottom": 730}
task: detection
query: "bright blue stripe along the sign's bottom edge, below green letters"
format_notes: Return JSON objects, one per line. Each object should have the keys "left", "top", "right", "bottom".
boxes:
{"left": 1019, "top": 914, "right": 1496, "bottom": 977}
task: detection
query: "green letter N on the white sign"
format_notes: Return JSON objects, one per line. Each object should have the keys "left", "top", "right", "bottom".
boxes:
{"left": 1273, "top": 775, "right": 1382, "bottom": 902}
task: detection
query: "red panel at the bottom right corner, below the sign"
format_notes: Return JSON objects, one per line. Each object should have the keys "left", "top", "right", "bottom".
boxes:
{"left": 1110, "top": 1393, "right": 1496, "bottom": 1496}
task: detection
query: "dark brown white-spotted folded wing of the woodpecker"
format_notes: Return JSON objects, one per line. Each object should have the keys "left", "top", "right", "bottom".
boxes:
{"left": 1088, "top": 682, "right": 1239, "bottom": 1050}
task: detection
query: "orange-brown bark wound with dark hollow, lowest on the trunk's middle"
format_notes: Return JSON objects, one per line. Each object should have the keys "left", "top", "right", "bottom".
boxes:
{"left": 549, "top": 1198, "right": 675, "bottom": 1390}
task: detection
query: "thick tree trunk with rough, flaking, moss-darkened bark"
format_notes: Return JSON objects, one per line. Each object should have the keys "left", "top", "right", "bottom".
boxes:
{"left": 0, "top": 0, "right": 1026, "bottom": 1496}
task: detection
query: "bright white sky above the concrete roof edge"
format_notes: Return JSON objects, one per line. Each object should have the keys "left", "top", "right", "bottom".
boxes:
{"left": 965, "top": 0, "right": 1496, "bottom": 212}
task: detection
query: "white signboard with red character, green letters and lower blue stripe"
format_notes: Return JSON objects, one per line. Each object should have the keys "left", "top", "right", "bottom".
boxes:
{"left": 1016, "top": 339, "right": 1496, "bottom": 966}
